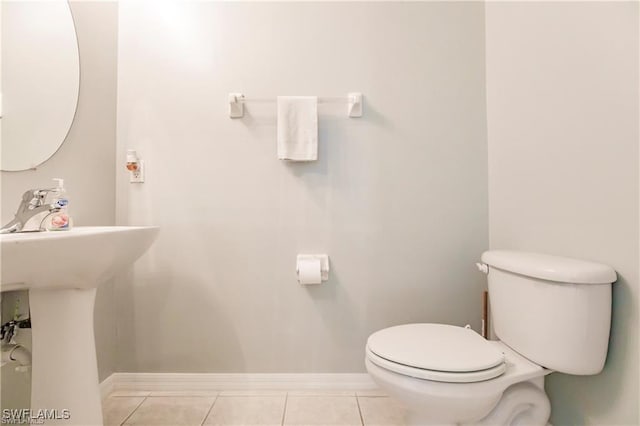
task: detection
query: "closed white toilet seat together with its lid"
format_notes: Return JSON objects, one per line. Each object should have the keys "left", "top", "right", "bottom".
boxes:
{"left": 367, "top": 324, "right": 506, "bottom": 383}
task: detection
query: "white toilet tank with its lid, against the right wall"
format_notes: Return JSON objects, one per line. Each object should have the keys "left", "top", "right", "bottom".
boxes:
{"left": 482, "top": 250, "right": 617, "bottom": 375}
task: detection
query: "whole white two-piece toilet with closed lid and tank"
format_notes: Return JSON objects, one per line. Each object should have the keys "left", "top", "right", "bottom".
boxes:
{"left": 365, "top": 250, "right": 617, "bottom": 426}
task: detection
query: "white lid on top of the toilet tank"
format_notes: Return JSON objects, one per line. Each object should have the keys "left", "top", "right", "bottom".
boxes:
{"left": 482, "top": 250, "right": 617, "bottom": 284}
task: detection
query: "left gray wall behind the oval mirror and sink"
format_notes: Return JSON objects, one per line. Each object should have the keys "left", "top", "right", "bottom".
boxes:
{"left": 1, "top": 2, "right": 118, "bottom": 379}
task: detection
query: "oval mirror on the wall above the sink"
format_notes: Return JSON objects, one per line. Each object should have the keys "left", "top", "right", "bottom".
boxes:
{"left": 0, "top": 0, "right": 80, "bottom": 171}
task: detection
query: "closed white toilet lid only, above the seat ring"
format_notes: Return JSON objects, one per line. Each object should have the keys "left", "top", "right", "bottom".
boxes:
{"left": 367, "top": 324, "right": 504, "bottom": 373}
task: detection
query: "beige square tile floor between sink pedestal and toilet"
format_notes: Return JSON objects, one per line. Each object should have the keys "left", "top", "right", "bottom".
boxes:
{"left": 103, "top": 391, "right": 406, "bottom": 426}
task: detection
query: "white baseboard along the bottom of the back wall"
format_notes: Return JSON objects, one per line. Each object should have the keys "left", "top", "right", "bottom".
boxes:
{"left": 100, "top": 373, "right": 377, "bottom": 396}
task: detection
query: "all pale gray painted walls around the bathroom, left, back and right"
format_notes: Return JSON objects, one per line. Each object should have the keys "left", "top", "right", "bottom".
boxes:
{"left": 1, "top": 2, "right": 640, "bottom": 425}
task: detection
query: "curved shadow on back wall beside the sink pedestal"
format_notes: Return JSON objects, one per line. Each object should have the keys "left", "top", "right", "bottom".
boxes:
{"left": 118, "top": 248, "right": 244, "bottom": 373}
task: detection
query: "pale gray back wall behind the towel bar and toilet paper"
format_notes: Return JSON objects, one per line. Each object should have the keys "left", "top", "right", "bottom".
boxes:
{"left": 117, "top": 2, "right": 488, "bottom": 373}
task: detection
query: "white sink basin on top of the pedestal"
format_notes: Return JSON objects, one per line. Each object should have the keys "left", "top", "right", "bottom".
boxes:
{"left": 0, "top": 226, "right": 158, "bottom": 291}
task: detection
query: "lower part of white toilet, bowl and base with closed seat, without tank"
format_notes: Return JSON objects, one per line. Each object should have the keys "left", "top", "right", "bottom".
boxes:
{"left": 365, "top": 324, "right": 551, "bottom": 425}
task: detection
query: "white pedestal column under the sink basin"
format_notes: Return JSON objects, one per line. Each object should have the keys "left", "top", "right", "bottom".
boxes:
{"left": 29, "top": 287, "right": 102, "bottom": 426}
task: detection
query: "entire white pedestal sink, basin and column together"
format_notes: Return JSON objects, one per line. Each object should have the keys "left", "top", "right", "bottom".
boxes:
{"left": 0, "top": 226, "right": 158, "bottom": 426}
